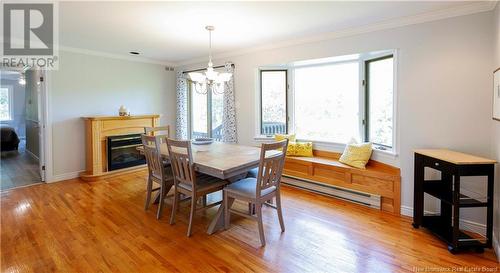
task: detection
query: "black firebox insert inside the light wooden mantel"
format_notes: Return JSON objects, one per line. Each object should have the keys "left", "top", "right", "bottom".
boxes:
{"left": 107, "top": 134, "right": 146, "bottom": 171}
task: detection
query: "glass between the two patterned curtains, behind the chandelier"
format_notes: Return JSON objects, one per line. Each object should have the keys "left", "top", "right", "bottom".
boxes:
{"left": 190, "top": 83, "right": 224, "bottom": 140}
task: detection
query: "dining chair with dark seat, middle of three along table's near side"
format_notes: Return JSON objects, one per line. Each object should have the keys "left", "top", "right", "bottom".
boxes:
{"left": 167, "top": 138, "right": 227, "bottom": 237}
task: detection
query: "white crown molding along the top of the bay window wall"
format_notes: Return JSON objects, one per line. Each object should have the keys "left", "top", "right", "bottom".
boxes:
{"left": 176, "top": 0, "right": 498, "bottom": 67}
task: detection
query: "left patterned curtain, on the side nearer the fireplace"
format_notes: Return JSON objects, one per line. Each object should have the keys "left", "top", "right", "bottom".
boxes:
{"left": 176, "top": 71, "right": 188, "bottom": 139}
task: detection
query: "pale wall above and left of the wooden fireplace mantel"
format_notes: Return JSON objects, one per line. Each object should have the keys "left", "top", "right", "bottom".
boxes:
{"left": 48, "top": 51, "right": 176, "bottom": 177}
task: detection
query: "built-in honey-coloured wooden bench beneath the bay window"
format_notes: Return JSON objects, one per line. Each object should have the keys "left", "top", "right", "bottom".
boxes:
{"left": 283, "top": 150, "right": 401, "bottom": 215}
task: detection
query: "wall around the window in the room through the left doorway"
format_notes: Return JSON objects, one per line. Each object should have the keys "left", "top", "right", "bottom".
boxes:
{"left": 1, "top": 79, "right": 26, "bottom": 138}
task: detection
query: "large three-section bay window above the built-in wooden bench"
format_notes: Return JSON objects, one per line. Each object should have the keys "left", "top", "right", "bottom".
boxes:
{"left": 260, "top": 50, "right": 395, "bottom": 152}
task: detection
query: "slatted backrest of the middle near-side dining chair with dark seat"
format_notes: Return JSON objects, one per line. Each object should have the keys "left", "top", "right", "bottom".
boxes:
{"left": 167, "top": 138, "right": 196, "bottom": 188}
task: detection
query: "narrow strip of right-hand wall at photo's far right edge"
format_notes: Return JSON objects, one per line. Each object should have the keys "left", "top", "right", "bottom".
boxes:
{"left": 492, "top": 0, "right": 500, "bottom": 260}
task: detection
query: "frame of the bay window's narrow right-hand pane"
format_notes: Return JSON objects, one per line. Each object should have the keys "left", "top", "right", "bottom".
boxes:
{"left": 363, "top": 54, "right": 396, "bottom": 151}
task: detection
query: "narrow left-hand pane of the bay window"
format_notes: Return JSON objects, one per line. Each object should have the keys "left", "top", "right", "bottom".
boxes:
{"left": 260, "top": 70, "right": 288, "bottom": 135}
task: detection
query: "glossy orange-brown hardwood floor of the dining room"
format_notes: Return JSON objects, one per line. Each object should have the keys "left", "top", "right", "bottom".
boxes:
{"left": 0, "top": 172, "right": 500, "bottom": 272}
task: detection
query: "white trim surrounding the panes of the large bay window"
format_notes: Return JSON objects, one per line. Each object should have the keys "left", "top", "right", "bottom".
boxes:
{"left": 254, "top": 49, "right": 399, "bottom": 156}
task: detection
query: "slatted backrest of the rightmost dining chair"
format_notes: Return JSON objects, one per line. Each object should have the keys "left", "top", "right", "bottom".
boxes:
{"left": 256, "top": 139, "right": 288, "bottom": 198}
